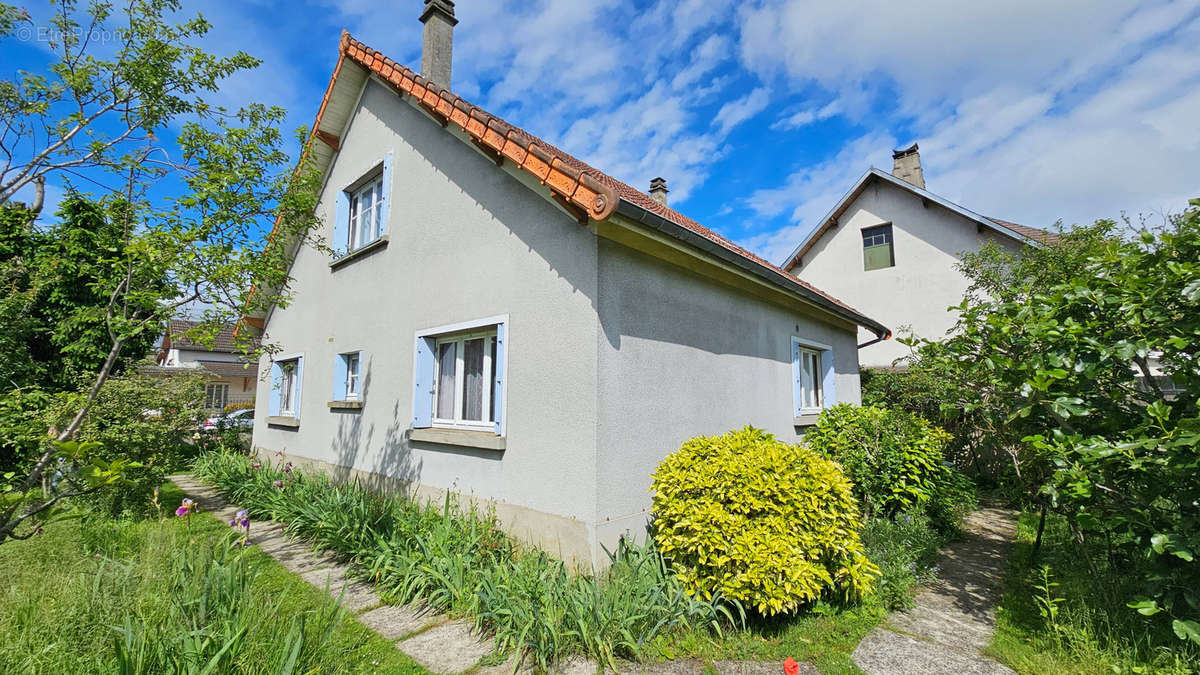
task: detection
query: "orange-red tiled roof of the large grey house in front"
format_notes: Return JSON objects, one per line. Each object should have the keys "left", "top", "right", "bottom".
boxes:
{"left": 244, "top": 31, "right": 890, "bottom": 336}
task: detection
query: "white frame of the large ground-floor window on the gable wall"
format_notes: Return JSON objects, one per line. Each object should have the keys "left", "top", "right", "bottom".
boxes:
{"left": 413, "top": 315, "right": 511, "bottom": 436}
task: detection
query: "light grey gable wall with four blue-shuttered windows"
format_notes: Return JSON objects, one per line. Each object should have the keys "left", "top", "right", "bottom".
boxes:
{"left": 253, "top": 82, "right": 609, "bottom": 563}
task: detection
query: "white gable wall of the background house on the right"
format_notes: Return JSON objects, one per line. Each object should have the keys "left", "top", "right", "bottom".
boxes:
{"left": 788, "top": 180, "right": 1019, "bottom": 368}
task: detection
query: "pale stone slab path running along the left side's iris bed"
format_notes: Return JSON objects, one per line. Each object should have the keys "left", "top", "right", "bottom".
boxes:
{"left": 170, "top": 474, "right": 817, "bottom": 675}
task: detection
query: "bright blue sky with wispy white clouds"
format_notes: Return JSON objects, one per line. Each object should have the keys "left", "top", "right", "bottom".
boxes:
{"left": 0, "top": 0, "right": 1200, "bottom": 262}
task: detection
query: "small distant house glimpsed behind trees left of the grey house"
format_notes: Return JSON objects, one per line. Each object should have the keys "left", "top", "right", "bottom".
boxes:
{"left": 152, "top": 318, "right": 258, "bottom": 411}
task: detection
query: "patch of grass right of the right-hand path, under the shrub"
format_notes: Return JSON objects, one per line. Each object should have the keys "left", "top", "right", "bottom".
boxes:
{"left": 988, "top": 513, "right": 1200, "bottom": 675}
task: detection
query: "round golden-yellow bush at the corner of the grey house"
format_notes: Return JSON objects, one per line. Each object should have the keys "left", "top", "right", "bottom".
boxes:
{"left": 653, "top": 426, "right": 878, "bottom": 615}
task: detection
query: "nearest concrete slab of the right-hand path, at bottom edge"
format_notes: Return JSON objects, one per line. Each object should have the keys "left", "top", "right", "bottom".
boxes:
{"left": 853, "top": 628, "right": 1015, "bottom": 675}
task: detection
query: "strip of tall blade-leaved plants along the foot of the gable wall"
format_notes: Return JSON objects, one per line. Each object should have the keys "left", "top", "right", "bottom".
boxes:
{"left": 196, "top": 453, "right": 744, "bottom": 667}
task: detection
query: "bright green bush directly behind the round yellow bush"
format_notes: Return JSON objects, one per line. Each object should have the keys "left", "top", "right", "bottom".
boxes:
{"left": 804, "top": 404, "right": 949, "bottom": 516}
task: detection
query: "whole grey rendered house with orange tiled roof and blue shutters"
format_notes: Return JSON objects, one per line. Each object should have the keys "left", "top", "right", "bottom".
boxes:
{"left": 242, "top": 5, "right": 888, "bottom": 566}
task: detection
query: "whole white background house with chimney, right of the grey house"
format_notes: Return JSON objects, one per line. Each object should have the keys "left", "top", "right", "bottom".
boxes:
{"left": 780, "top": 143, "right": 1058, "bottom": 366}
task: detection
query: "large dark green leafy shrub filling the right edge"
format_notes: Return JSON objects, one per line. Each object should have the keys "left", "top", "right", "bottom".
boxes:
{"left": 914, "top": 201, "right": 1200, "bottom": 643}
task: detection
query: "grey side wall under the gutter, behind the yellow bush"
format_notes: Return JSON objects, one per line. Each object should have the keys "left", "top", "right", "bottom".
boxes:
{"left": 596, "top": 240, "right": 859, "bottom": 549}
